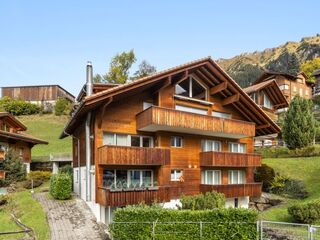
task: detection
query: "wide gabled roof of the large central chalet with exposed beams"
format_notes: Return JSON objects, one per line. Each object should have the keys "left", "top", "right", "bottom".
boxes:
{"left": 60, "top": 57, "right": 280, "bottom": 138}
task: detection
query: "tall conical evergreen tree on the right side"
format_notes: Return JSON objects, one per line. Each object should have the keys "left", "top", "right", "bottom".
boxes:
{"left": 282, "top": 96, "right": 315, "bottom": 149}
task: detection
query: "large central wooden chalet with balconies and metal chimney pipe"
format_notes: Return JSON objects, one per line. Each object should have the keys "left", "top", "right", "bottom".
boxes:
{"left": 61, "top": 58, "right": 280, "bottom": 223}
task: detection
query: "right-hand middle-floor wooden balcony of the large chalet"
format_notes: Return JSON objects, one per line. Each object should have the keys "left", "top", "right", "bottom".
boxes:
{"left": 200, "top": 152, "right": 261, "bottom": 167}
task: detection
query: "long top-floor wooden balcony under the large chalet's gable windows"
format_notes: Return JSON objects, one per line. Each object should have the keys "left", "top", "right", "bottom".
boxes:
{"left": 136, "top": 106, "right": 255, "bottom": 138}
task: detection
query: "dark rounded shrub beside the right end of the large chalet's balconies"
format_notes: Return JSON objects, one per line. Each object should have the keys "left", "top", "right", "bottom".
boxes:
{"left": 254, "top": 164, "right": 276, "bottom": 192}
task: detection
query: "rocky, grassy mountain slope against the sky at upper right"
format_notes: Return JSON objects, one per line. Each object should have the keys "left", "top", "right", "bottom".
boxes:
{"left": 217, "top": 34, "right": 320, "bottom": 87}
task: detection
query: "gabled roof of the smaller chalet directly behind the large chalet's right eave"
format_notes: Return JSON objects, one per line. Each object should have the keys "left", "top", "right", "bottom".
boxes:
{"left": 243, "top": 79, "right": 289, "bottom": 109}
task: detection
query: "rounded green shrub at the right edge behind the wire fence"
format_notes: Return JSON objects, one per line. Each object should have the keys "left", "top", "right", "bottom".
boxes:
{"left": 288, "top": 200, "right": 320, "bottom": 224}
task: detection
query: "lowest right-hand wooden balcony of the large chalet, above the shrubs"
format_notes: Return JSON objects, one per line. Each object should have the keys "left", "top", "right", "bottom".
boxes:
{"left": 200, "top": 183, "right": 262, "bottom": 198}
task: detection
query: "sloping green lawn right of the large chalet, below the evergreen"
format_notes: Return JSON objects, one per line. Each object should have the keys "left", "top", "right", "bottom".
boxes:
{"left": 261, "top": 157, "right": 320, "bottom": 221}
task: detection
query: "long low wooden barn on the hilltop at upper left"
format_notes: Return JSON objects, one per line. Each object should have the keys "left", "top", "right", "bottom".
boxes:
{"left": 2, "top": 85, "right": 75, "bottom": 105}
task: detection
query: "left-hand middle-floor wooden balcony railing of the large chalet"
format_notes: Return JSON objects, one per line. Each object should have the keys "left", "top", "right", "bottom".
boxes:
{"left": 98, "top": 145, "right": 170, "bottom": 166}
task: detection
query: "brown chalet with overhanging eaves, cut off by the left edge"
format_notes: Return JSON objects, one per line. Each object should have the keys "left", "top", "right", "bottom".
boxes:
{"left": 0, "top": 112, "right": 48, "bottom": 178}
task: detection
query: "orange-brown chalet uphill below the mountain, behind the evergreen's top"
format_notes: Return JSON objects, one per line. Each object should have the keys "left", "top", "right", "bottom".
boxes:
{"left": 253, "top": 72, "right": 313, "bottom": 103}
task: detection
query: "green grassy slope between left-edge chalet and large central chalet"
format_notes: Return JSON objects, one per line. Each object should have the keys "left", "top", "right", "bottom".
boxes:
{"left": 19, "top": 114, "right": 71, "bottom": 157}
